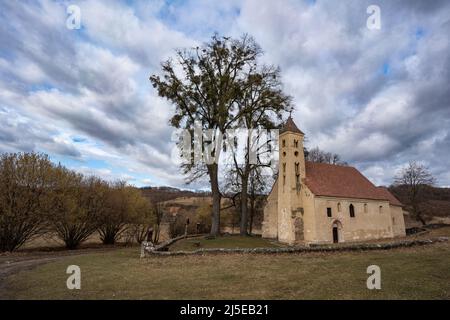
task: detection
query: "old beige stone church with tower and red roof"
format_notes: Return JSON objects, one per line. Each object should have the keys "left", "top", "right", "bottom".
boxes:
{"left": 262, "top": 117, "right": 405, "bottom": 244}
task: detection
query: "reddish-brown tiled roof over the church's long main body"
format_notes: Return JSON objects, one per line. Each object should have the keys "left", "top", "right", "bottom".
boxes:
{"left": 305, "top": 161, "right": 402, "bottom": 206}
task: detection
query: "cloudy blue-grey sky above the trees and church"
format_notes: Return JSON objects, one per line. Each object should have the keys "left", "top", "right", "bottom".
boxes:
{"left": 0, "top": 0, "right": 450, "bottom": 187}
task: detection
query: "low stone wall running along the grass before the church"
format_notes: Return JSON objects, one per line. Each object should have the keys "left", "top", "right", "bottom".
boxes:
{"left": 141, "top": 236, "right": 449, "bottom": 257}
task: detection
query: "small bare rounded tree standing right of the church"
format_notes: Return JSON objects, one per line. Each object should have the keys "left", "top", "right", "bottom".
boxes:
{"left": 394, "top": 161, "right": 436, "bottom": 225}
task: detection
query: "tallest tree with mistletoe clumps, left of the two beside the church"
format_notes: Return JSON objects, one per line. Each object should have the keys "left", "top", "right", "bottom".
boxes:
{"left": 150, "top": 35, "right": 270, "bottom": 236}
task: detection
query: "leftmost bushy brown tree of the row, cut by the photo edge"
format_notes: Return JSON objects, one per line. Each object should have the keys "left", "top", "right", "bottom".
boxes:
{"left": 0, "top": 153, "right": 53, "bottom": 251}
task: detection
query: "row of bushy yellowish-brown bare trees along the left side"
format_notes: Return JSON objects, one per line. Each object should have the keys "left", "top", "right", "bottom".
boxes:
{"left": 0, "top": 153, "right": 156, "bottom": 251}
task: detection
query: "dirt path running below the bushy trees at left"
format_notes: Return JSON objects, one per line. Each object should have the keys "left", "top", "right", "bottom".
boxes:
{"left": 0, "top": 247, "right": 126, "bottom": 300}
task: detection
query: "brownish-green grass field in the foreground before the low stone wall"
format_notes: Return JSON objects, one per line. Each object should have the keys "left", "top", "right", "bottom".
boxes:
{"left": 5, "top": 228, "right": 450, "bottom": 299}
